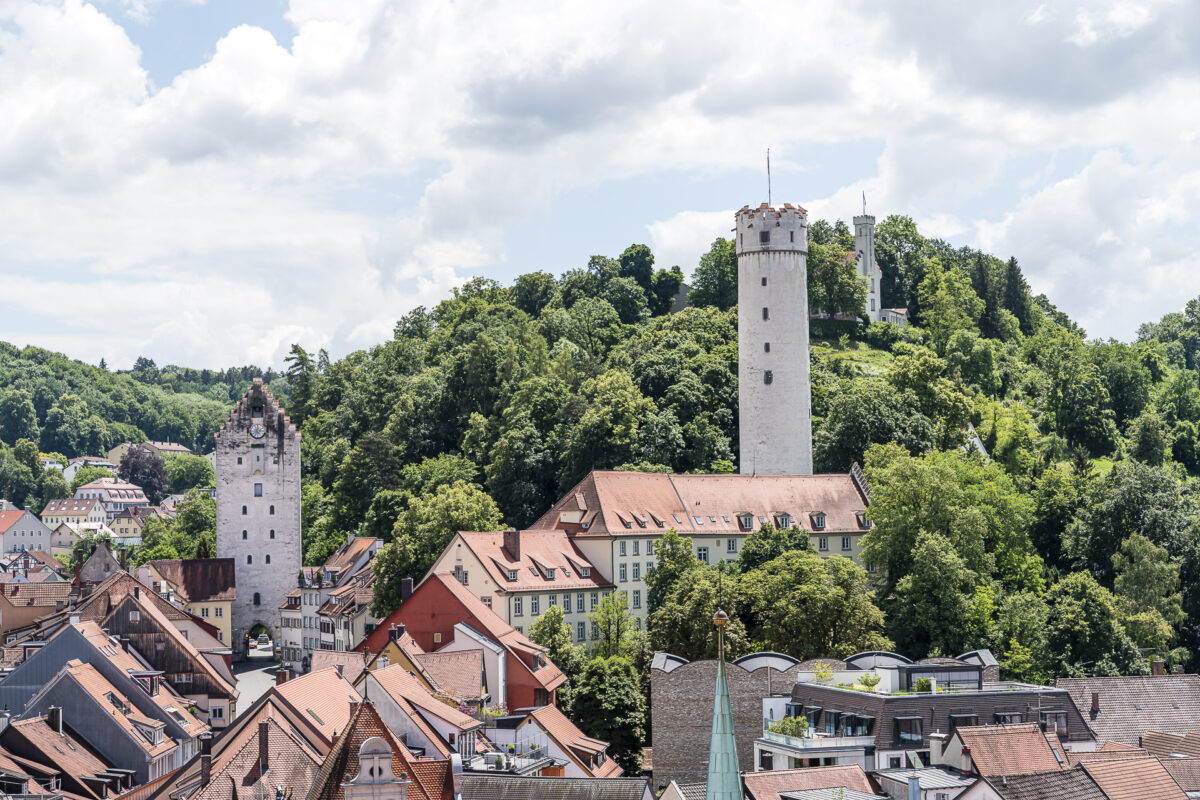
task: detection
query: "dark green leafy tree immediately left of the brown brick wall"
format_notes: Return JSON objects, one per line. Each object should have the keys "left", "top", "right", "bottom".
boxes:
{"left": 574, "top": 656, "right": 646, "bottom": 775}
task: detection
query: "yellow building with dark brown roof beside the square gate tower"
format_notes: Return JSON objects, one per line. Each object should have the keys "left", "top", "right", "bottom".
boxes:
{"left": 137, "top": 559, "right": 236, "bottom": 644}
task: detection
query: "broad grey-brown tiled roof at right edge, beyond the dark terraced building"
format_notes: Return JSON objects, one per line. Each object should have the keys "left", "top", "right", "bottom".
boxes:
{"left": 1055, "top": 675, "right": 1200, "bottom": 747}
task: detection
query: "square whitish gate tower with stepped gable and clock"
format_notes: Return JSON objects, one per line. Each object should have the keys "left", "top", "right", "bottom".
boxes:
{"left": 216, "top": 378, "right": 300, "bottom": 658}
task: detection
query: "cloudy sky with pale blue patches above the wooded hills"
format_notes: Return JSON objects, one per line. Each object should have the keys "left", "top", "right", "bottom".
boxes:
{"left": 0, "top": 0, "right": 1200, "bottom": 368}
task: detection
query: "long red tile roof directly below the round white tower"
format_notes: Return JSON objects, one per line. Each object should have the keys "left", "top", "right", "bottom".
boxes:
{"left": 530, "top": 470, "right": 866, "bottom": 536}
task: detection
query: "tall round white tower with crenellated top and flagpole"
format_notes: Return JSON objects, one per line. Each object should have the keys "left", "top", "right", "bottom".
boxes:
{"left": 734, "top": 203, "right": 812, "bottom": 475}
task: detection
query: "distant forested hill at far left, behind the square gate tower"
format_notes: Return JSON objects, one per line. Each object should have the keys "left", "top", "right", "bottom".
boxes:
{"left": 0, "top": 342, "right": 287, "bottom": 460}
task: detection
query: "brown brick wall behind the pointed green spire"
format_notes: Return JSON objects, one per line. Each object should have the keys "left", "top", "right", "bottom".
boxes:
{"left": 650, "top": 660, "right": 798, "bottom": 787}
